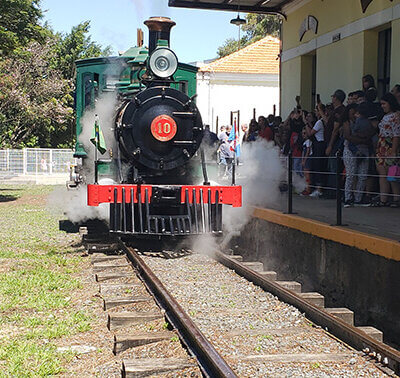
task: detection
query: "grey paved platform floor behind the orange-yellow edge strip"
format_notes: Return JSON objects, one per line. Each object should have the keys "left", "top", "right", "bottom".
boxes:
{"left": 270, "top": 193, "right": 400, "bottom": 241}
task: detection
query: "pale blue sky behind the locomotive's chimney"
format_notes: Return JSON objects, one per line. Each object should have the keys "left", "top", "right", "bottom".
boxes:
{"left": 41, "top": 0, "right": 242, "bottom": 62}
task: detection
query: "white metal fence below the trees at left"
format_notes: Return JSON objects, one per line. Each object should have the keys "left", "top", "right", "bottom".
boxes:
{"left": 0, "top": 148, "right": 76, "bottom": 181}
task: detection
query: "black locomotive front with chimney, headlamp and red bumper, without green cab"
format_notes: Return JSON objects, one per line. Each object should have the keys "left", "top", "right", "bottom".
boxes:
{"left": 73, "top": 17, "right": 242, "bottom": 238}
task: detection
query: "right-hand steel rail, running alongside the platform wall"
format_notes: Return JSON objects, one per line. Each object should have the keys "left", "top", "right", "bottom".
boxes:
{"left": 213, "top": 251, "right": 400, "bottom": 375}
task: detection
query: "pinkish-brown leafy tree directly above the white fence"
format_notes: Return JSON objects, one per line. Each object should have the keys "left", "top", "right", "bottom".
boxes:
{"left": 0, "top": 41, "right": 73, "bottom": 148}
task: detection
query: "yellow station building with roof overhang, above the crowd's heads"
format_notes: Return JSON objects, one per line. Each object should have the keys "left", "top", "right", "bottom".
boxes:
{"left": 169, "top": 0, "right": 400, "bottom": 117}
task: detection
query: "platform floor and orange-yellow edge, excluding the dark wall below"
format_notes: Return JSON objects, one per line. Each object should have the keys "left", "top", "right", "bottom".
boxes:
{"left": 253, "top": 196, "right": 400, "bottom": 261}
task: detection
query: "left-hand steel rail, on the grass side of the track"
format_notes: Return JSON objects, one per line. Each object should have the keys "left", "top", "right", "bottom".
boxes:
{"left": 121, "top": 242, "right": 237, "bottom": 378}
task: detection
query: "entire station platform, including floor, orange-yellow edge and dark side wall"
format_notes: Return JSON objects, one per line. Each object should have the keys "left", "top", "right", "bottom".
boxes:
{"left": 234, "top": 199, "right": 400, "bottom": 345}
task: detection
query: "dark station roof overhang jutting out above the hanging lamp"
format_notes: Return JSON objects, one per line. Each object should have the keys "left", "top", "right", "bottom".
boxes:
{"left": 168, "top": 0, "right": 297, "bottom": 17}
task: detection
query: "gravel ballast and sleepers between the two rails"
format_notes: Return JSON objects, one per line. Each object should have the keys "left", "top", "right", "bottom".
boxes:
{"left": 142, "top": 254, "right": 385, "bottom": 377}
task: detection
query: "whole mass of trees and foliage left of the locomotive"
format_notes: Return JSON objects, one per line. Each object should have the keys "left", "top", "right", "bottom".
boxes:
{"left": 0, "top": 0, "right": 111, "bottom": 148}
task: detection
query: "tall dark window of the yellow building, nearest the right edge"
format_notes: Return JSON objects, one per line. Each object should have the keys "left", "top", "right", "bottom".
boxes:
{"left": 378, "top": 29, "right": 392, "bottom": 97}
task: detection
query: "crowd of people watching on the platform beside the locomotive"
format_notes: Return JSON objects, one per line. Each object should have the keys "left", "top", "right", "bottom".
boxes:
{"left": 206, "top": 75, "right": 400, "bottom": 207}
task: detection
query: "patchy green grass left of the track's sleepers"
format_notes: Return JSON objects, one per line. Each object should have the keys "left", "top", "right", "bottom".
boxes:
{"left": 0, "top": 185, "right": 92, "bottom": 377}
